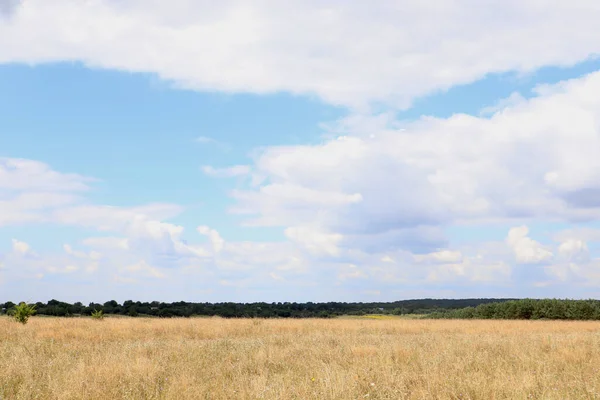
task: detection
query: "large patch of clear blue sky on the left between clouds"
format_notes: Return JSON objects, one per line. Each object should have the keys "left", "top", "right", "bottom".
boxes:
{"left": 0, "top": 63, "right": 343, "bottom": 246}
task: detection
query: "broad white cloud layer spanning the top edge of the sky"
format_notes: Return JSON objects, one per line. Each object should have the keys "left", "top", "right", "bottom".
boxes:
{"left": 0, "top": 0, "right": 600, "bottom": 107}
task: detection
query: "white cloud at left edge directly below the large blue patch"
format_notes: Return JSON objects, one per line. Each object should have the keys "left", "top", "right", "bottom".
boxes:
{"left": 0, "top": 158, "right": 214, "bottom": 273}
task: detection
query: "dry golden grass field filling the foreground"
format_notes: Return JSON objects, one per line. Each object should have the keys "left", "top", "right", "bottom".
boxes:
{"left": 0, "top": 317, "right": 600, "bottom": 400}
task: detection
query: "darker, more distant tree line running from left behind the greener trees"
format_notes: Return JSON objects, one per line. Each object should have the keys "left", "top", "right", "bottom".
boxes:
{"left": 0, "top": 299, "right": 510, "bottom": 318}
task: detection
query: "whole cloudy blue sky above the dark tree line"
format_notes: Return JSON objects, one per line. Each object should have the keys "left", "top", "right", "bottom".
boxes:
{"left": 0, "top": 0, "right": 600, "bottom": 302}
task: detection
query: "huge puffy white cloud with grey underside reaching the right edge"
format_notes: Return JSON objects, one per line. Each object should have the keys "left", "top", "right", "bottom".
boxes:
{"left": 225, "top": 73, "right": 600, "bottom": 253}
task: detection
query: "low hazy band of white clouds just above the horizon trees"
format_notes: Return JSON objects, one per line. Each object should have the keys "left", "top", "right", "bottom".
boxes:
{"left": 0, "top": 220, "right": 600, "bottom": 301}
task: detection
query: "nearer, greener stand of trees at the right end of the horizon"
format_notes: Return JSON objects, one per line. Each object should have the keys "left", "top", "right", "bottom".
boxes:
{"left": 427, "top": 299, "right": 600, "bottom": 320}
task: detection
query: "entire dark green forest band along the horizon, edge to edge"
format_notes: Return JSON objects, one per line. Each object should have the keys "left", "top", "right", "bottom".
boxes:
{"left": 0, "top": 299, "right": 600, "bottom": 320}
